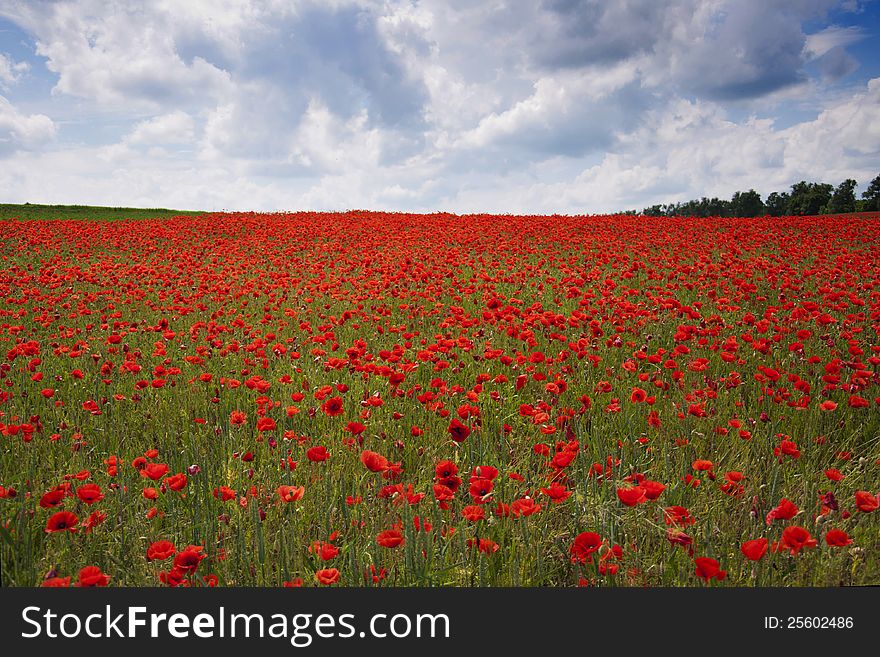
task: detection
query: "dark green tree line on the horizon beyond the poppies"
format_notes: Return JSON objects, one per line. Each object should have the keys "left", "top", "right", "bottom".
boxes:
{"left": 628, "top": 175, "right": 880, "bottom": 217}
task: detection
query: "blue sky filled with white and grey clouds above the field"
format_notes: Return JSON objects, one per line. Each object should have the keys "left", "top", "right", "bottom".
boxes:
{"left": 0, "top": 0, "right": 880, "bottom": 213}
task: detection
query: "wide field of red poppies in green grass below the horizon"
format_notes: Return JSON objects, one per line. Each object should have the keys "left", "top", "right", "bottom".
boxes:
{"left": 0, "top": 212, "right": 880, "bottom": 587}
